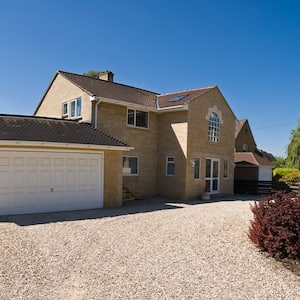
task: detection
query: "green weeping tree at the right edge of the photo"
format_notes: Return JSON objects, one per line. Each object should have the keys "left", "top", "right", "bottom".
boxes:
{"left": 285, "top": 123, "right": 300, "bottom": 170}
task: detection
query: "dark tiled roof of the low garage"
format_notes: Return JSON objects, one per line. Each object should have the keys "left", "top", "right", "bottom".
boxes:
{"left": 0, "top": 115, "right": 128, "bottom": 147}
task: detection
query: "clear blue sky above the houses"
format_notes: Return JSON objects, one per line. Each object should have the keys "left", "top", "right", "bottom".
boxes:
{"left": 0, "top": 0, "right": 300, "bottom": 156}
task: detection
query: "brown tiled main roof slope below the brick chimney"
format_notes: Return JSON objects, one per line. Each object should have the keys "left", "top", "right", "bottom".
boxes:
{"left": 58, "top": 71, "right": 158, "bottom": 108}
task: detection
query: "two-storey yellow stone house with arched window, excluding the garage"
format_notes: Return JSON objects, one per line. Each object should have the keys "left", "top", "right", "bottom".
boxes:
{"left": 34, "top": 71, "right": 236, "bottom": 200}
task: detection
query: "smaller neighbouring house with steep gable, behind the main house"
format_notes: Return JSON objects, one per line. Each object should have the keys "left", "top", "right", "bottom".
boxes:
{"left": 234, "top": 120, "right": 273, "bottom": 193}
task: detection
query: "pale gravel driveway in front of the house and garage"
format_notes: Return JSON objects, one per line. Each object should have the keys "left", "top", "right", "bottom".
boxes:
{"left": 0, "top": 199, "right": 300, "bottom": 300}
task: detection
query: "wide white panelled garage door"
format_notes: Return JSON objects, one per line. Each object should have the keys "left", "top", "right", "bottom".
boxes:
{"left": 0, "top": 151, "right": 103, "bottom": 215}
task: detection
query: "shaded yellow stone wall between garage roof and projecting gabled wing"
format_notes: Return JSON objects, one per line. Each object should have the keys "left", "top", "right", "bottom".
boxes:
{"left": 97, "top": 102, "right": 157, "bottom": 198}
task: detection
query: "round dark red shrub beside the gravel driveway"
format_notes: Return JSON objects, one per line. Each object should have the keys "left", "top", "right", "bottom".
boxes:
{"left": 248, "top": 191, "right": 300, "bottom": 259}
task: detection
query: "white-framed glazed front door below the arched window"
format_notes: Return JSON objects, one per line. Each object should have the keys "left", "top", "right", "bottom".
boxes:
{"left": 205, "top": 158, "right": 220, "bottom": 194}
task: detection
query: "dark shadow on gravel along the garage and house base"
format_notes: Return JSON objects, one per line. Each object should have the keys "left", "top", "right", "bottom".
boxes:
{"left": 0, "top": 195, "right": 259, "bottom": 226}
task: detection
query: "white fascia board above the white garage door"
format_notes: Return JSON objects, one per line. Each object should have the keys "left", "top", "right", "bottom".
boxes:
{"left": 0, "top": 141, "right": 134, "bottom": 151}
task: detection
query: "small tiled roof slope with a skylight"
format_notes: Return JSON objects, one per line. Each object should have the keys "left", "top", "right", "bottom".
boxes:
{"left": 157, "top": 86, "right": 215, "bottom": 108}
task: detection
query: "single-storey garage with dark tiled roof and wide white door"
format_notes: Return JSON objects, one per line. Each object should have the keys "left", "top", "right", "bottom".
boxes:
{"left": 0, "top": 115, "right": 131, "bottom": 215}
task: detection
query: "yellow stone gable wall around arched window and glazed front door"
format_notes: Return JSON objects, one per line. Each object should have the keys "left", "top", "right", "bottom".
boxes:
{"left": 186, "top": 89, "right": 235, "bottom": 199}
